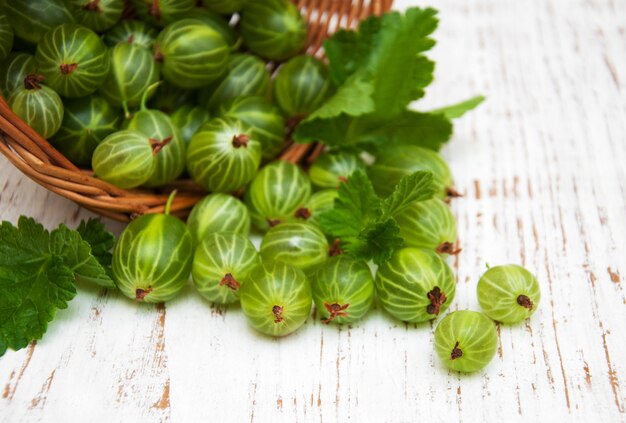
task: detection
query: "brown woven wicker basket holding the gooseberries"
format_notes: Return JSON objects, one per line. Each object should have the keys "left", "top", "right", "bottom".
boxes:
{"left": 0, "top": 0, "right": 393, "bottom": 221}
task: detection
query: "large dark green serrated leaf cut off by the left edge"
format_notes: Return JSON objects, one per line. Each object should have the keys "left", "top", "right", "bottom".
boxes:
{"left": 0, "top": 217, "right": 76, "bottom": 356}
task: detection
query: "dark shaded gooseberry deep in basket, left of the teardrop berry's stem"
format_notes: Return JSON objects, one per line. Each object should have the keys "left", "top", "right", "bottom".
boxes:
{"left": 50, "top": 95, "right": 121, "bottom": 166}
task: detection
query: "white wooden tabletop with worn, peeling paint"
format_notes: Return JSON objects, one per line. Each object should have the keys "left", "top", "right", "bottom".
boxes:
{"left": 0, "top": 0, "right": 626, "bottom": 422}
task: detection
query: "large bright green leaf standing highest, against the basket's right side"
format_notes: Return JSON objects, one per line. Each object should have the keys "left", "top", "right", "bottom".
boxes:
{"left": 294, "top": 8, "right": 436, "bottom": 146}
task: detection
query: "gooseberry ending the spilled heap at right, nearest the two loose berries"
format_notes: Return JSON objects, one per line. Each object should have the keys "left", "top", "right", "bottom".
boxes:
{"left": 376, "top": 247, "right": 456, "bottom": 323}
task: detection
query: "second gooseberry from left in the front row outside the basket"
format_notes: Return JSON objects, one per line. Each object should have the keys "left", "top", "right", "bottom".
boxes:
{"left": 191, "top": 232, "right": 261, "bottom": 304}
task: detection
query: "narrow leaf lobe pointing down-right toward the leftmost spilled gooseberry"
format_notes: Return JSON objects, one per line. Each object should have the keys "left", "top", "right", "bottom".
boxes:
{"left": 50, "top": 224, "right": 115, "bottom": 288}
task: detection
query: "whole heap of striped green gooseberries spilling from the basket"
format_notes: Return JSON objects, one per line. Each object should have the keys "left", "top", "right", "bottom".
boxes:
{"left": 0, "top": 0, "right": 540, "bottom": 371}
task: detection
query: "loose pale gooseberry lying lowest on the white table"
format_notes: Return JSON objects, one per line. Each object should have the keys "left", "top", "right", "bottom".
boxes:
{"left": 435, "top": 310, "right": 498, "bottom": 373}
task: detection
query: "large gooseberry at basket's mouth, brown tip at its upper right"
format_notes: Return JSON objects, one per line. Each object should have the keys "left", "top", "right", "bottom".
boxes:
{"left": 187, "top": 118, "right": 261, "bottom": 192}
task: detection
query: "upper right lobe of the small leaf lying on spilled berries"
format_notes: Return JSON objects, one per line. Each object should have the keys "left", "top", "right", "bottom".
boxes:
{"left": 383, "top": 170, "right": 436, "bottom": 217}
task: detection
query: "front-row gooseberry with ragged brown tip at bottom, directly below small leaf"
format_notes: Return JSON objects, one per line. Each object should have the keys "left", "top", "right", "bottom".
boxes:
{"left": 310, "top": 255, "right": 374, "bottom": 324}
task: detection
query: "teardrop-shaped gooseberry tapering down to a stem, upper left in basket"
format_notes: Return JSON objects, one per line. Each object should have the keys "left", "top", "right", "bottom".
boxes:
{"left": 98, "top": 43, "right": 159, "bottom": 112}
